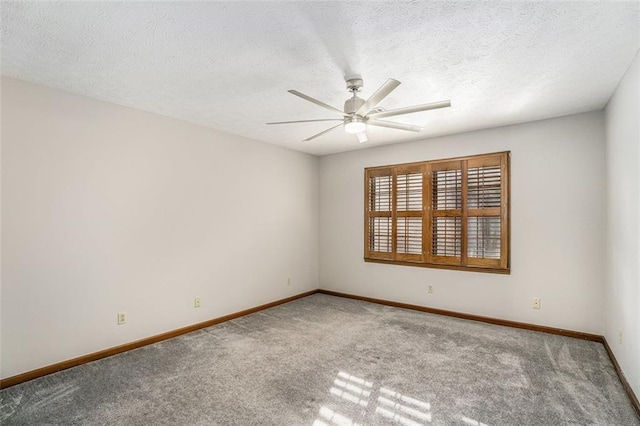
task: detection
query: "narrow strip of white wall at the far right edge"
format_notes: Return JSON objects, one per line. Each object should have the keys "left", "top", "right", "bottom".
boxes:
{"left": 604, "top": 53, "right": 640, "bottom": 396}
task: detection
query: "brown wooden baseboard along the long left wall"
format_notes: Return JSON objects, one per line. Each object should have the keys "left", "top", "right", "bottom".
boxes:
{"left": 0, "top": 290, "right": 317, "bottom": 389}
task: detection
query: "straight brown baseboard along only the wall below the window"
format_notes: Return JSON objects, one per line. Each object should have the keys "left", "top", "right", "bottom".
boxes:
{"left": 318, "top": 289, "right": 603, "bottom": 343}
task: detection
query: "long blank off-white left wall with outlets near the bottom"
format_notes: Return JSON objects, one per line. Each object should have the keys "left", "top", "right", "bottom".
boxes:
{"left": 1, "top": 78, "right": 318, "bottom": 378}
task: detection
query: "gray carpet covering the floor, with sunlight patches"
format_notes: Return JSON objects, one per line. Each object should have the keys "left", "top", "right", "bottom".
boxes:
{"left": 0, "top": 294, "right": 640, "bottom": 426}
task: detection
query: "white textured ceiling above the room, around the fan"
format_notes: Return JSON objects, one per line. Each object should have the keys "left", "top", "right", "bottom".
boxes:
{"left": 1, "top": 1, "right": 640, "bottom": 155}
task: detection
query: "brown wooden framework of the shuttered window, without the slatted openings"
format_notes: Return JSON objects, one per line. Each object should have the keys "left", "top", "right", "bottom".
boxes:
{"left": 364, "top": 151, "right": 511, "bottom": 274}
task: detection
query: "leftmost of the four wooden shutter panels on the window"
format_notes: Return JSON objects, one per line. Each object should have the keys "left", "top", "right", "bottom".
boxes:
{"left": 364, "top": 168, "right": 394, "bottom": 259}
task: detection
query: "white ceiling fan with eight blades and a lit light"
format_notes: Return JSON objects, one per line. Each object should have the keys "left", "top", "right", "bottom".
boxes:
{"left": 267, "top": 76, "right": 451, "bottom": 143}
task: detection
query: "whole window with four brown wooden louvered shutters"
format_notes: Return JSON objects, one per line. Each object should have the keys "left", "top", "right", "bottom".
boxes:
{"left": 364, "top": 152, "right": 509, "bottom": 273}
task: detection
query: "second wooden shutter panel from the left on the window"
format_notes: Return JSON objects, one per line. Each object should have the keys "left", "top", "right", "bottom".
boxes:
{"left": 394, "top": 165, "right": 424, "bottom": 261}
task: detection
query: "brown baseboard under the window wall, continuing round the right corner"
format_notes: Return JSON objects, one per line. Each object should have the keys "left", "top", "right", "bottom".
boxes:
{"left": 317, "top": 289, "right": 640, "bottom": 417}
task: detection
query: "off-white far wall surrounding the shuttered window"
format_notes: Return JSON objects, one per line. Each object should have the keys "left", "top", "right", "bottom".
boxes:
{"left": 320, "top": 112, "right": 605, "bottom": 334}
